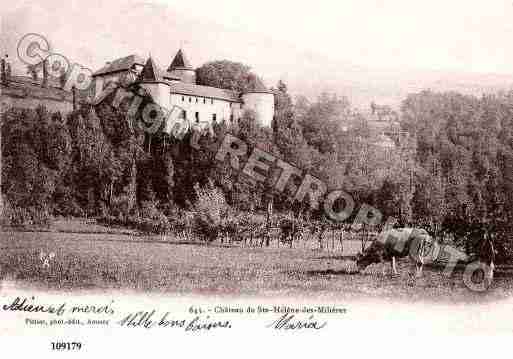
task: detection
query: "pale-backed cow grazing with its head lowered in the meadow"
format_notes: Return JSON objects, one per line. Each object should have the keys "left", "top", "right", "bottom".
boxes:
{"left": 356, "top": 228, "right": 433, "bottom": 277}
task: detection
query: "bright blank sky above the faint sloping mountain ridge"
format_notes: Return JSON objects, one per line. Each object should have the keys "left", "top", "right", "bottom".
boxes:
{"left": 165, "top": 0, "right": 513, "bottom": 72}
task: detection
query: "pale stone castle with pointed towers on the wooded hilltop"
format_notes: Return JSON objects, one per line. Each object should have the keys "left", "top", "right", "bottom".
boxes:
{"left": 93, "top": 49, "right": 274, "bottom": 127}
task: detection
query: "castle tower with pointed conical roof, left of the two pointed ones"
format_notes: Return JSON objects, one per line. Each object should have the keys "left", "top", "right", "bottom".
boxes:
{"left": 137, "top": 56, "right": 171, "bottom": 110}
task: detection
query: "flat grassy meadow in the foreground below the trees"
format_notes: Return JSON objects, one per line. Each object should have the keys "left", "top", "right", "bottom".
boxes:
{"left": 0, "top": 232, "right": 513, "bottom": 302}
